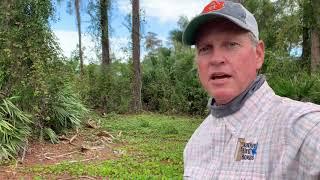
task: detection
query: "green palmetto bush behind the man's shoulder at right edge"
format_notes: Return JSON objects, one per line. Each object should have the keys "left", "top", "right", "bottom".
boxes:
{"left": 262, "top": 52, "right": 320, "bottom": 103}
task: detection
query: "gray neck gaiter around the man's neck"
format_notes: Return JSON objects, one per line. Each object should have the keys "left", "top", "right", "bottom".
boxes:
{"left": 209, "top": 75, "right": 265, "bottom": 118}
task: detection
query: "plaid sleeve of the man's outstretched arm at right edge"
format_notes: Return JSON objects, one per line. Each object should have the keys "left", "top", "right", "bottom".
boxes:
{"left": 281, "top": 98, "right": 320, "bottom": 175}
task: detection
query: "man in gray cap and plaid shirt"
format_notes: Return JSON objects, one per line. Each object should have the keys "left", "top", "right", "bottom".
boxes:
{"left": 183, "top": 0, "right": 320, "bottom": 180}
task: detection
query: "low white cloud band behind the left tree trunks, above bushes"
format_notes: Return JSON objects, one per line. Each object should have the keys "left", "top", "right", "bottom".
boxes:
{"left": 54, "top": 30, "right": 130, "bottom": 64}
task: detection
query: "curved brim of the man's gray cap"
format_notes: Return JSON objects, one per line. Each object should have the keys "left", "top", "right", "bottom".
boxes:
{"left": 182, "top": 12, "right": 250, "bottom": 45}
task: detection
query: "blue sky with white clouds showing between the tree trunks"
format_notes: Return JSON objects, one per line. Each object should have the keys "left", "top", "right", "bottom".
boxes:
{"left": 50, "top": 0, "right": 210, "bottom": 64}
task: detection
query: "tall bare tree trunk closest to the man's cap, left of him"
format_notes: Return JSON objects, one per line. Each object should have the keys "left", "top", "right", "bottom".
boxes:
{"left": 131, "top": 0, "right": 142, "bottom": 112}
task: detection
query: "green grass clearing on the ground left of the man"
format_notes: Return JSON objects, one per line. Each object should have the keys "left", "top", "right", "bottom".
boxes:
{"left": 29, "top": 114, "right": 201, "bottom": 179}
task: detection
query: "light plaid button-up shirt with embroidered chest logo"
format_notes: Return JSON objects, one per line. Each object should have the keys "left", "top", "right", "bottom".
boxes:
{"left": 184, "top": 82, "right": 320, "bottom": 180}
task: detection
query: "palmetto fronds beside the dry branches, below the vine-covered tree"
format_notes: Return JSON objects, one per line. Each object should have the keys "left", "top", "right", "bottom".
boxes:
{"left": 35, "top": 86, "right": 89, "bottom": 143}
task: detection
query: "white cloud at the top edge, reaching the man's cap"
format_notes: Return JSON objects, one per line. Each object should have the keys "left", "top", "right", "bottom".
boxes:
{"left": 118, "top": 0, "right": 210, "bottom": 22}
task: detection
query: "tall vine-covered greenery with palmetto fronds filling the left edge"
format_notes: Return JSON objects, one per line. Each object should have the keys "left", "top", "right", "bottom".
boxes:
{"left": 0, "top": 0, "right": 86, "bottom": 160}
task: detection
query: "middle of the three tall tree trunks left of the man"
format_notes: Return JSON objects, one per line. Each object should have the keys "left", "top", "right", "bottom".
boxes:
{"left": 100, "top": 0, "right": 111, "bottom": 66}
